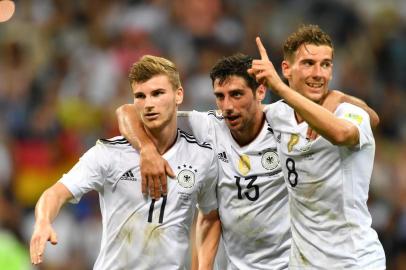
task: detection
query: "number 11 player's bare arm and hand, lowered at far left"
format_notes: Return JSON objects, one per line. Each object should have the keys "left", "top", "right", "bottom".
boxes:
{"left": 30, "top": 182, "right": 73, "bottom": 264}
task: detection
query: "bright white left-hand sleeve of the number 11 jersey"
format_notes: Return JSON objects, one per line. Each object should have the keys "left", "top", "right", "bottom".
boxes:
{"left": 59, "top": 143, "right": 108, "bottom": 203}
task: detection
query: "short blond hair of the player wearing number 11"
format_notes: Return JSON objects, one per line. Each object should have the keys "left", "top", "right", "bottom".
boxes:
{"left": 128, "top": 55, "right": 181, "bottom": 90}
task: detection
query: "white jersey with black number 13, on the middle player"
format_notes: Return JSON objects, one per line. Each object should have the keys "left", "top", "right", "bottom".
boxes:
{"left": 178, "top": 111, "right": 290, "bottom": 270}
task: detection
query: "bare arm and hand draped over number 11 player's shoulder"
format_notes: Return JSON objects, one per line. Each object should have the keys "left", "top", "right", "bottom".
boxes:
{"left": 116, "top": 104, "right": 174, "bottom": 200}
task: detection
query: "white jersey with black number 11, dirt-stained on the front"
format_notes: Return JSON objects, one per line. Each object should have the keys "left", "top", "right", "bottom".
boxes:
{"left": 60, "top": 130, "right": 218, "bottom": 270}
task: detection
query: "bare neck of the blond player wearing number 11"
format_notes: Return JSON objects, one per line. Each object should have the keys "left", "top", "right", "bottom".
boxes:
{"left": 145, "top": 117, "right": 178, "bottom": 155}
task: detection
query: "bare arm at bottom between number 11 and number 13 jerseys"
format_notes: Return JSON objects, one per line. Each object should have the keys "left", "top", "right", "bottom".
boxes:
{"left": 196, "top": 210, "right": 221, "bottom": 270}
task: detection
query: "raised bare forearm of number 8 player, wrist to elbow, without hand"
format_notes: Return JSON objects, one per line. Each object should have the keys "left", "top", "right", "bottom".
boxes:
{"left": 274, "top": 82, "right": 359, "bottom": 145}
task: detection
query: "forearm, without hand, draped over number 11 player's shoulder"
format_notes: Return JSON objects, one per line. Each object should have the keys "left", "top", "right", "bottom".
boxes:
{"left": 116, "top": 104, "right": 154, "bottom": 150}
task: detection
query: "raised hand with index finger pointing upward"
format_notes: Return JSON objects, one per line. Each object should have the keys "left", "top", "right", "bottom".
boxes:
{"left": 247, "top": 37, "right": 283, "bottom": 90}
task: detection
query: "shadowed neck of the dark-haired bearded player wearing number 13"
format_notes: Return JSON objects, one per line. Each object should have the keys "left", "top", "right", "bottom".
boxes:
{"left": 231, "top": 110, "right": 265, "bottom": 146}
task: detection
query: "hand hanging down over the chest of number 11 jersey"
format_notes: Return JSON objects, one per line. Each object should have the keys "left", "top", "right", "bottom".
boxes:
{"left": 140, "top": 144, "right": 175, "bottom": 200}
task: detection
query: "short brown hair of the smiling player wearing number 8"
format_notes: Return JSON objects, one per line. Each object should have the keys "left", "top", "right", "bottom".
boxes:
{"left": 283, "top": 24, "right": 334, "bottom": 61}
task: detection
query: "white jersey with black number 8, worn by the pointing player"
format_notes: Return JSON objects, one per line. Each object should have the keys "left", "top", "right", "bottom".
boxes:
{"left": 266, "top": 101, "right": 385, "bottom": 270}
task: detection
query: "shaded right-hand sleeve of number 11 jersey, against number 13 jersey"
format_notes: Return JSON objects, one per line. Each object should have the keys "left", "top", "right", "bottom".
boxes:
{"left": 197, "top": 152, "right": 218, "bottom": 214}
